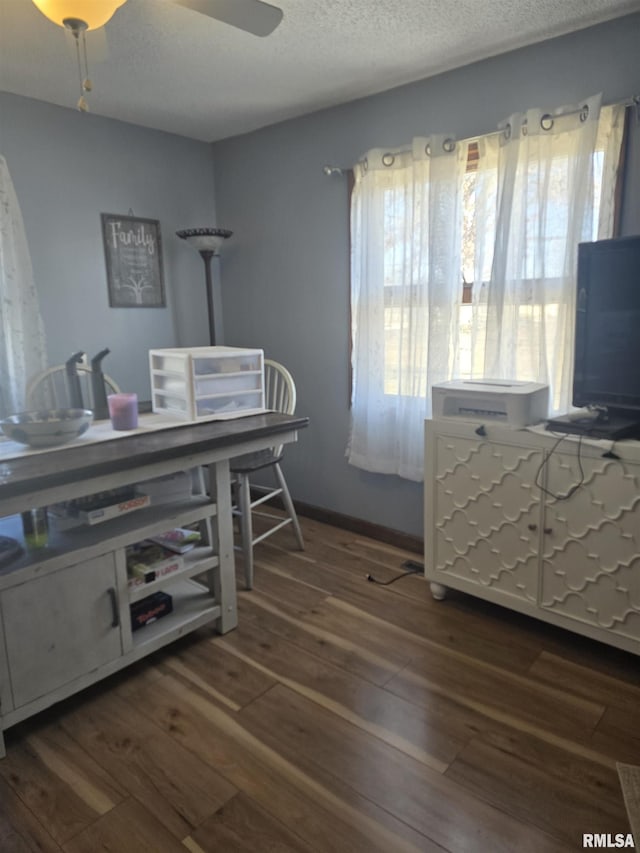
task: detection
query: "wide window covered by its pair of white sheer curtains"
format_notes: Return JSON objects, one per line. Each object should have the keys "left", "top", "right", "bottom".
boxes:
{"left": 348, "top": 96, "right": 624, "bottom": 479}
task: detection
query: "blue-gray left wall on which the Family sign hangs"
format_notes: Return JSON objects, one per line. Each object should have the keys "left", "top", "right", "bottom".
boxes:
{"left": 0, "top": 93, "right": 215, "bottom": 400}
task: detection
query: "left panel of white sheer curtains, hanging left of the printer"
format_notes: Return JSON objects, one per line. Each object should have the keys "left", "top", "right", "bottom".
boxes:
{"left": 347, "top": 136, "right": 467, "bottom": 480}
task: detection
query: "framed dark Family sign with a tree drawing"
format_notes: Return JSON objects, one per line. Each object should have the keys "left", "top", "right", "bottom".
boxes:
{"left": 101, "top": 213, "right": 166, "bottom": 308}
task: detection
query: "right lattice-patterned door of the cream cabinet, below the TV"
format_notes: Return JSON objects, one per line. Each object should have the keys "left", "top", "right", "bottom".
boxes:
{"left": 541, "top": 448, "right": 640, "bottom": 639}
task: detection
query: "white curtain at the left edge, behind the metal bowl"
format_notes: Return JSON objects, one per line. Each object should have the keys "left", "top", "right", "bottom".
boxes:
{"left": 0, "top": 156, "right": 46, "bottom": 417}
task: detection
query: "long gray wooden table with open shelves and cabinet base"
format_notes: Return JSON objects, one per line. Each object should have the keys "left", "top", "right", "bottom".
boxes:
{"left": 0, "top": 413, "right": 308, "bottom": 756}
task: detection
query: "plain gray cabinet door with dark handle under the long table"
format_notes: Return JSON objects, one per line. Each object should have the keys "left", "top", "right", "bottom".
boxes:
{"left": 0, "top": 554, "right": 122, "bottom": 708}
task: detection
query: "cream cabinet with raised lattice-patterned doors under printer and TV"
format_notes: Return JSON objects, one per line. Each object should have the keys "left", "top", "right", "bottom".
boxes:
{"left": 425, "top": 419, "right": 640, "bottom": 654}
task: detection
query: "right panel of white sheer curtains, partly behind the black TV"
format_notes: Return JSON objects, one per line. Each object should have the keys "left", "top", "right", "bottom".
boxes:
{"left": 471, "top": 95, "right": 624, "bottom": 414}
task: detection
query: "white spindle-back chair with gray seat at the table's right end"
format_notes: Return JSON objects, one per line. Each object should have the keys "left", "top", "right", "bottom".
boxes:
{"left": 230, "top": 359, "right": 304, "bottom": 589}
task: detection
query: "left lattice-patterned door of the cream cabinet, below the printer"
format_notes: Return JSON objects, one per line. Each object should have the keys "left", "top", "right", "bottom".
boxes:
{"left": 426, "top": 434, "right": 542, "bottom": 604}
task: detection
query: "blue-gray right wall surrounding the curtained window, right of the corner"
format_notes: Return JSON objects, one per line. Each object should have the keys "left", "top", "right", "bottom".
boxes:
{"left": 214, "top": 10, "right": 640, "bottom": 535}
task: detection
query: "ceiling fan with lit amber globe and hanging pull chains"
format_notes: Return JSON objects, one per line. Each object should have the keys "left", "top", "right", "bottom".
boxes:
{"left": 33, "top": 0, "right": 282, "bottom": 112}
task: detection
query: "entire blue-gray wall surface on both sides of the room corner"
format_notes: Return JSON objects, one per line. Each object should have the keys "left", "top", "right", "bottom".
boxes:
{"left": 0, "top": 15, "right": 640, "bottom": 535}
